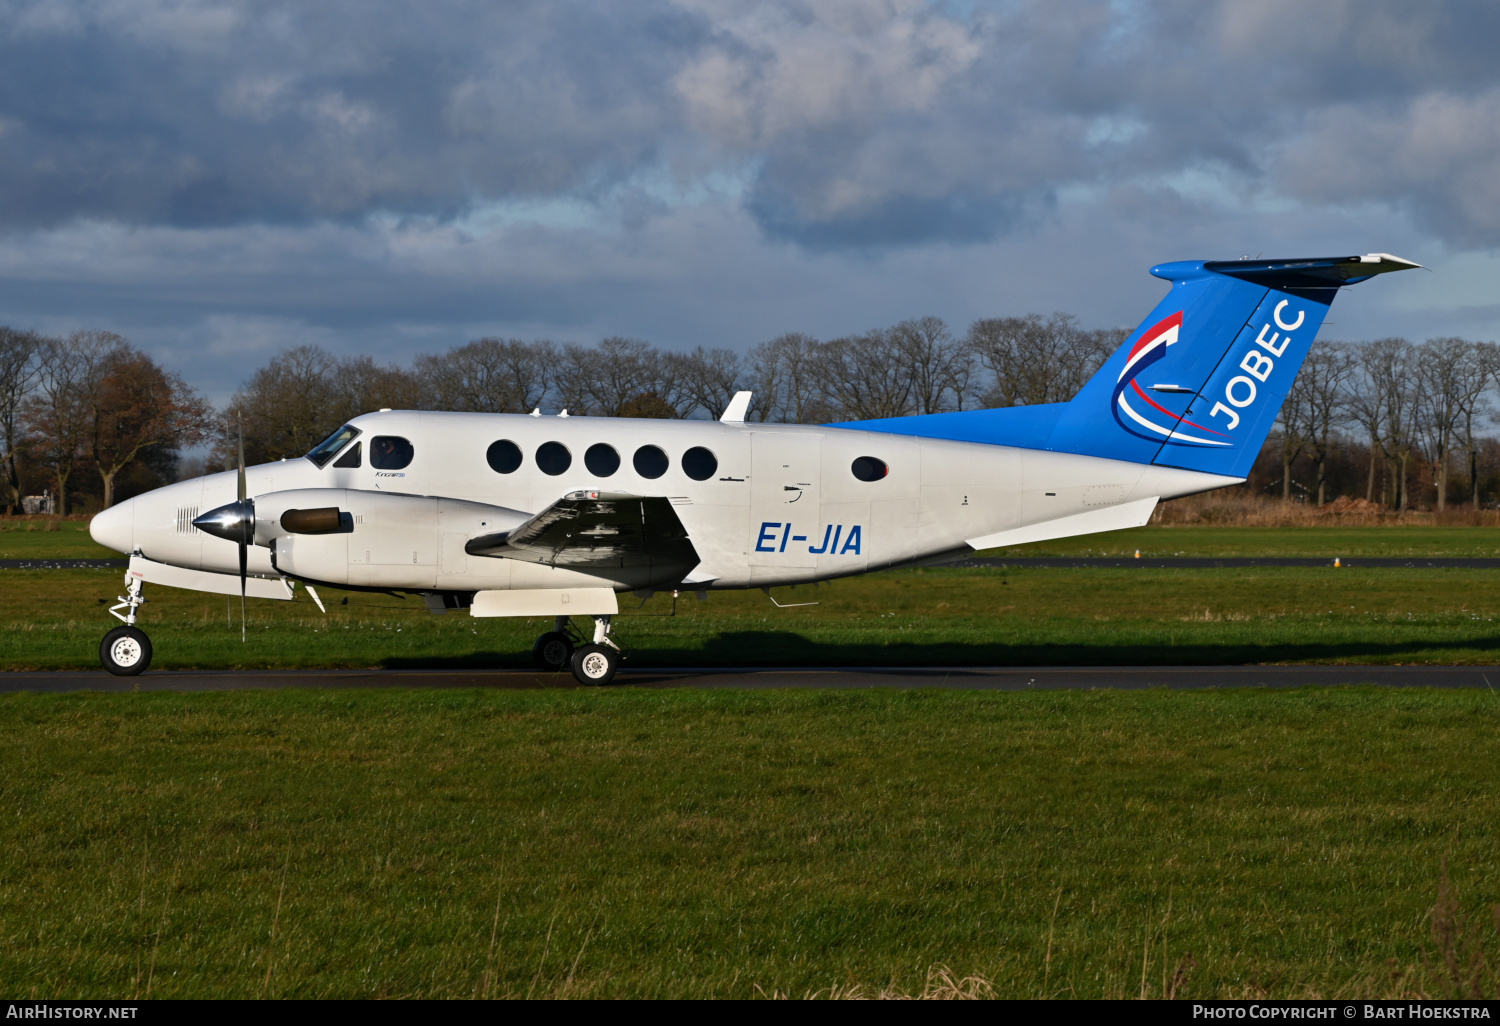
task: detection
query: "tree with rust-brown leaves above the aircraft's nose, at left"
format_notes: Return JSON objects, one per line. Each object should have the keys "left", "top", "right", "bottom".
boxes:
{"left": 87, "top": 347, "right": 210, "bottom": 509}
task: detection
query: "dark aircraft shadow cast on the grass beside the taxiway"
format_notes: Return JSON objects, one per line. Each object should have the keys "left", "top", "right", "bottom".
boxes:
{"left": 381, "top": 630, "right": 1500, "bottom": 669}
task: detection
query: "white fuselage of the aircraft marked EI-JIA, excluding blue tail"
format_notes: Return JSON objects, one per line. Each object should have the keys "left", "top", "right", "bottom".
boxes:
{"left": 92, "top": 411, "right": 1238, "bottom": 591}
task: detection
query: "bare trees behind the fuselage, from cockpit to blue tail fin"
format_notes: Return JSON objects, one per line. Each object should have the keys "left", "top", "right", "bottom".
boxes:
{"left": 230, "top": 314, "right": 1128, "bottom": 459}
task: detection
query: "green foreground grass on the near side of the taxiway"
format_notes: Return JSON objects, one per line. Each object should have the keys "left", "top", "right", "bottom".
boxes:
{"left": 0, "top": 689, "right": 1500, "bottom": 998}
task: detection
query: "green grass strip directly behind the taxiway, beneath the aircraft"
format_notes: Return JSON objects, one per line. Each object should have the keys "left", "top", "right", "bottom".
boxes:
{"left": 0, "top": 567, "right": 1500, "bottom": 669}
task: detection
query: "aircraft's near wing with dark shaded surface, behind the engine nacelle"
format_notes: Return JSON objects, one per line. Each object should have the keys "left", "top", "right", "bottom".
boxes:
{"left": 464, "top": 491, "right": 699, "bottom": 572}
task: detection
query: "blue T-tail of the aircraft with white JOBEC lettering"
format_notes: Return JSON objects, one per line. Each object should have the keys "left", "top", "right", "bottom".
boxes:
{"left": 839, "top": 254, "right": 1419, "bottom": 477}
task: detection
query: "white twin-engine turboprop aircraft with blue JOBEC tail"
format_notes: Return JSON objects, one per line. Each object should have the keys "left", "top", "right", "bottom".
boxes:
{"left": 90, "top": 254, "right": 1418, "bottom": 684}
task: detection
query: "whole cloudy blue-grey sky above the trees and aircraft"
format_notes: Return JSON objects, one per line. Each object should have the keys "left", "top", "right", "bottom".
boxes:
{"left": 0, "top": 0, "right": 1500, "bottom": 399}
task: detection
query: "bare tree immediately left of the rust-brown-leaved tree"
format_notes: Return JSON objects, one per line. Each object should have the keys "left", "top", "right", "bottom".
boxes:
{"left": 24, "top": 332, "right": 128, "bottom": 513}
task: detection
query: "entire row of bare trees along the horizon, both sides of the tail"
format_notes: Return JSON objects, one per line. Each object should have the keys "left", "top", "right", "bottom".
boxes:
{"left": 0, "top": 314, "right": 1500, "bottom": 512}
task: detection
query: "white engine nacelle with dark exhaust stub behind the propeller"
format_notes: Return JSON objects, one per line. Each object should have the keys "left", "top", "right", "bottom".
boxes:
{"left": 255, "top": 488, "right": 531, "bottom": 588}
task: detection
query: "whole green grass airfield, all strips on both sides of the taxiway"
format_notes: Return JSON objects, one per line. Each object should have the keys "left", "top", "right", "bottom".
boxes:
{"left": 0, "top": 525, "right": 1500, "bottom": 998}
